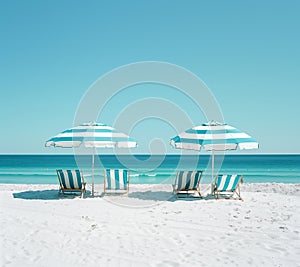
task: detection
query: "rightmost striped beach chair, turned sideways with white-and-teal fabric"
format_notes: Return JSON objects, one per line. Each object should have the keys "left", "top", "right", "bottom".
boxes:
{"left": 213, "top": 174, "right": 243, "bottom": 200}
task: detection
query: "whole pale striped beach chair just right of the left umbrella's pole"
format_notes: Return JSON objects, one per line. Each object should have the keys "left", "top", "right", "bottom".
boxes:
{"left": 104, "top": 169, "right": 130, "bottom": 195}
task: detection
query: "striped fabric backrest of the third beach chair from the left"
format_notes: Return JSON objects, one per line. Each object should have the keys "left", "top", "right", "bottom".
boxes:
{"left": 175, "top": 171, "right": 202, "bottom": 190}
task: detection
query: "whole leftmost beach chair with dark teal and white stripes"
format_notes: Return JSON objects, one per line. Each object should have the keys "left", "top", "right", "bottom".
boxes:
{"left": 56, "top": 170, "right": 86, "bottom": 197}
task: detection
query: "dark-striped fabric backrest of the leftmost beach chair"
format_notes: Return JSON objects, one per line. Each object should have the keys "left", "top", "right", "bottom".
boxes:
{"left": 56, "top": 170, "right": 84, "bottom": 189}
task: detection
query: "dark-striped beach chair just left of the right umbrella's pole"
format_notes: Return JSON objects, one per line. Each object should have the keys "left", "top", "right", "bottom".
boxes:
{"left": 173, "top": 170, "right": 202, "bottom": 197}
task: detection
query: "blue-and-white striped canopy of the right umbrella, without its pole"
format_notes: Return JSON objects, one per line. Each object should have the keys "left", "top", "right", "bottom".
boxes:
{"left": 171, "top": 121, "right": 258, "bottom": 151}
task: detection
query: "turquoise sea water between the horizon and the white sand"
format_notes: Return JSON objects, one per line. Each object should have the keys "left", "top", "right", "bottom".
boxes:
{"left": 0, "top": 155, "right": 300, "bottom": 184}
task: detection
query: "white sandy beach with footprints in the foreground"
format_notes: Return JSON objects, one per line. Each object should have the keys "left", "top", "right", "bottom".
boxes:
{"left": 0, "top": 184, "right": 300, "bottom": 267}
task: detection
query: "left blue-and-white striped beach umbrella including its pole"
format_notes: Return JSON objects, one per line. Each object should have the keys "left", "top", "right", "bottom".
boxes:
{"left": 45, "top": 122, "right": 137, "bottom": 195}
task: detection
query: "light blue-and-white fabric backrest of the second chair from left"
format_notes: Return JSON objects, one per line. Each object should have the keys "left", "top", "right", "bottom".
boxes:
{"left": 104, "top": 169, "right": 129, "bottom": 190}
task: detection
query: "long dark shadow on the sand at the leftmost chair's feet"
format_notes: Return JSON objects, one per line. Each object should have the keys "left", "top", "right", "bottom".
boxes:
{"left": 13, "top": 189, "right": 91, "bottom": 200}
